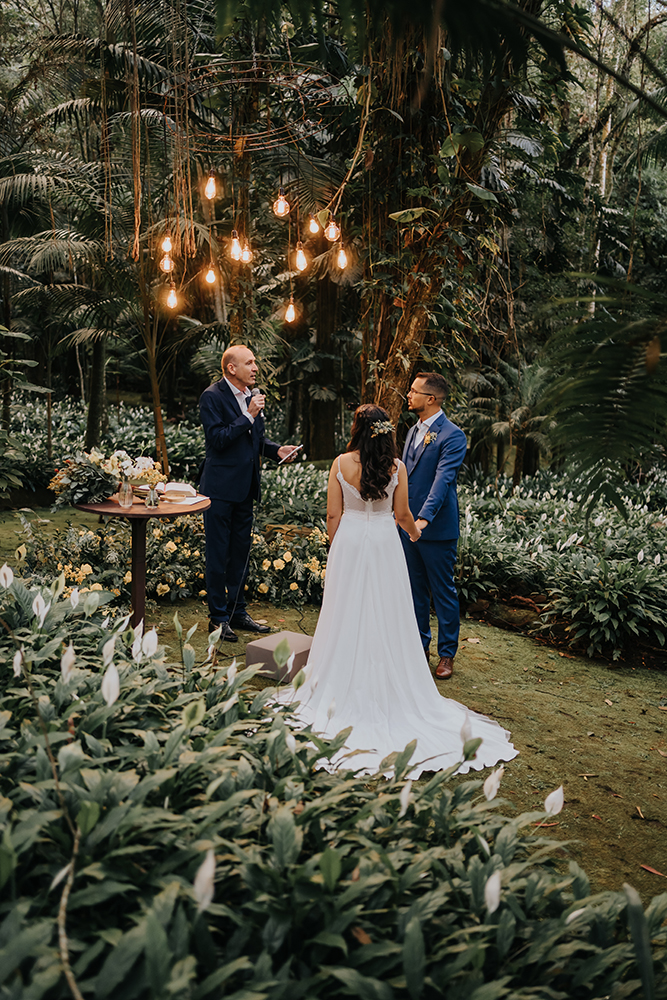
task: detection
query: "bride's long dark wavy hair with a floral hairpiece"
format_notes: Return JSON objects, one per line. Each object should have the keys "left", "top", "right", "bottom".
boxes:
{"left": 347, "top": 403, "right": 398, "bottom": 500}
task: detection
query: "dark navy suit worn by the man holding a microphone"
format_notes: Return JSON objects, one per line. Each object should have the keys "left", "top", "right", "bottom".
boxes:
{"left": 199, "top": 378, "right": 279, "bottom": 622}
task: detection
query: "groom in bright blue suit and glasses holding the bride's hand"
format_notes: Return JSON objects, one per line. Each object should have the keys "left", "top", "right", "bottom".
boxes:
{"left": 400, "top": 372, "right": 466, "bottom": 680}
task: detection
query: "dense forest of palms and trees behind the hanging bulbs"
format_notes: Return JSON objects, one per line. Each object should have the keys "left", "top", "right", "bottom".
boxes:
{"left": 0, "top": 0, "right": 667, "bottom": 495}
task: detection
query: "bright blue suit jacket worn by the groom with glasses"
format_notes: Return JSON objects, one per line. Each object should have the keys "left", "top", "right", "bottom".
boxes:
{"left": 403, "top": 413, "right": 466, "bottom": 542}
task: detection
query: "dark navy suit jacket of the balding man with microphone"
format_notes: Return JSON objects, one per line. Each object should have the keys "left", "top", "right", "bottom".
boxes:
{"left": 199, "top": 378, "right": 279, "bottom": 503}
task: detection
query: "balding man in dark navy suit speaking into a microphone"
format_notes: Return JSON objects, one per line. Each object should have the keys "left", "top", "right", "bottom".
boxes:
{"left": 199, "top": 345, "right": 298, "bottom": 642}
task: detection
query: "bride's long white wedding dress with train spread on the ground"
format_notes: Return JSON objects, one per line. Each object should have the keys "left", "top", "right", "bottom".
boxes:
{"left": 279, "top": 462, "right": 518, "bottom": 778}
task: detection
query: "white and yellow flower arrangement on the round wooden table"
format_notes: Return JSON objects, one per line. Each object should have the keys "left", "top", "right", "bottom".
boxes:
{"left": 49, "top": 448, "right": 167, "bottom": 507}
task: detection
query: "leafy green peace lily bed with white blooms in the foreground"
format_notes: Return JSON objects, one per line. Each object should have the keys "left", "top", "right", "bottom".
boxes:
{"left": 0, "top": 577, "right": 667, "bottom": 1000}
